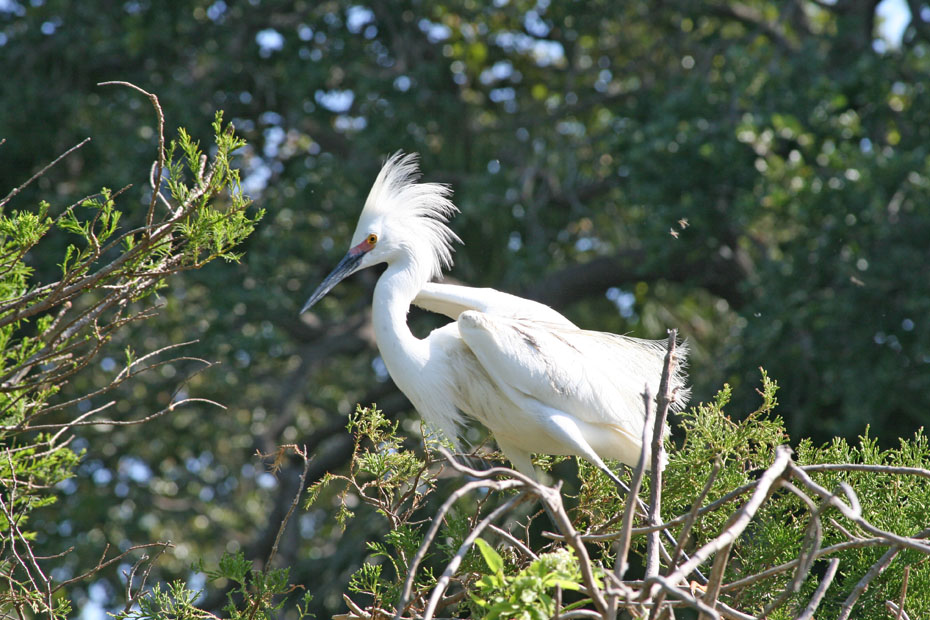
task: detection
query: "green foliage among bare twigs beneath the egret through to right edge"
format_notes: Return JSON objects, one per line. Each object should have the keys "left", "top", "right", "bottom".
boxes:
{"left": 320, "top": 378, "right": 930, "bottom": 620}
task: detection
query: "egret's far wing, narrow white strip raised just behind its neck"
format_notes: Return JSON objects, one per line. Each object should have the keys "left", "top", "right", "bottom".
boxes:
{"left": 413, "top": 282, "right": 577, "bottom": 329}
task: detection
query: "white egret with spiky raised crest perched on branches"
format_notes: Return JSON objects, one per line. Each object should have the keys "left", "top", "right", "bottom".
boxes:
{"left": 300, "top": 151, "right": 689, "bottom": 487}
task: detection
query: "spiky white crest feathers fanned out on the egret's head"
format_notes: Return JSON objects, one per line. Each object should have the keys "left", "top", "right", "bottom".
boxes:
{"left": 359, "top": 151, "right": 462, "bottom": 279}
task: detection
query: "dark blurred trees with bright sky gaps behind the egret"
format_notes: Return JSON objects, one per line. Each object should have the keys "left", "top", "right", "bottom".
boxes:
{"left": 0, "top": 0, "right": 930, "bottom": 611}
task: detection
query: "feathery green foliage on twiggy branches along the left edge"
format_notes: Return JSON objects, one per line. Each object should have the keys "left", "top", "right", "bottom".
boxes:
{"left": 0, "top": 94, "right": 260, "bottom": 618}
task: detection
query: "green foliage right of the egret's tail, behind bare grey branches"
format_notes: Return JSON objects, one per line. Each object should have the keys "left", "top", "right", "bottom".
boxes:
{"left": 663, "top": 371, "right": 930, "bottom": 618}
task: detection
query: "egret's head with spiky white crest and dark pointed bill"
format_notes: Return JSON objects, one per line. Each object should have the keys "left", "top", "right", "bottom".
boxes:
{"left": 300, "top": 151, "right": 461, "bottom": 314}
